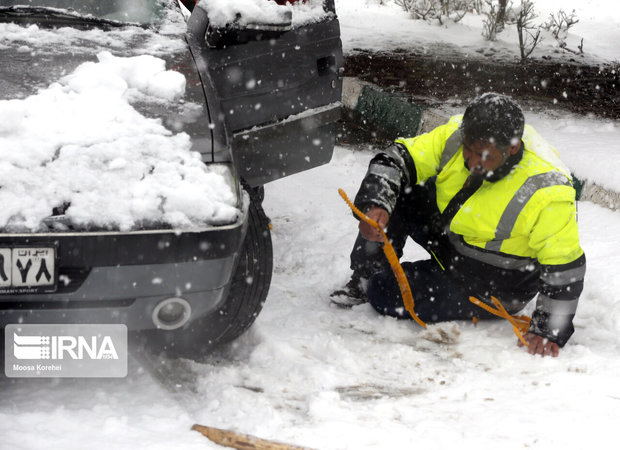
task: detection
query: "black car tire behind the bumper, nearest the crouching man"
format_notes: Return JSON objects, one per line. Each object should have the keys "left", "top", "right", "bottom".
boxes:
{"left": 138, "top": 187, "right": 273, "bottom": 359}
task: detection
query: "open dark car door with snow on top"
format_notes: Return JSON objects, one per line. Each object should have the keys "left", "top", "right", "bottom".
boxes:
{"left": 188, "top": 0, "right": 343, "bottom": 186}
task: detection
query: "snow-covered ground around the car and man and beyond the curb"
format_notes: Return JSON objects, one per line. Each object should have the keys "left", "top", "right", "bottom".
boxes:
{"left": 0, "top": 0, "right": 620, "bottom": 449}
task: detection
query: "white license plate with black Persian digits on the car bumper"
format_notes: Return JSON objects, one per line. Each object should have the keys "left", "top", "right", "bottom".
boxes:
{"left": 0, "top": 247, "right": 56, "bottom": 294}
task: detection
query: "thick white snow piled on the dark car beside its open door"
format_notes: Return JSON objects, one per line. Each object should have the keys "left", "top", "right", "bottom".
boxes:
{"left": 0, "top": 52, "right": 239, "bottom": 231}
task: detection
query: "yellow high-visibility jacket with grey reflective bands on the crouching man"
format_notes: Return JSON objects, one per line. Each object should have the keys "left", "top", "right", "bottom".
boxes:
{"left": 358, "top": 116, "right": 585, "bottom": 345}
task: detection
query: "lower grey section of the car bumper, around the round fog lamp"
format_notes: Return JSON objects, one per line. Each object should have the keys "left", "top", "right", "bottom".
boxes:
{"left": 0, "top": 255, "right": 234, "bottom": 330}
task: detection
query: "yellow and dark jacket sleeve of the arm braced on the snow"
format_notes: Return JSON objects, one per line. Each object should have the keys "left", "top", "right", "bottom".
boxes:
{"left": 530, "top": 201, "right": 586, "bottom": 347}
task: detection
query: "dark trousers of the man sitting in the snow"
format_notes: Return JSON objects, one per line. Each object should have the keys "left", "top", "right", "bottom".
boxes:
{"left": 351, "top": 180, "right": 494, "bottom": 323}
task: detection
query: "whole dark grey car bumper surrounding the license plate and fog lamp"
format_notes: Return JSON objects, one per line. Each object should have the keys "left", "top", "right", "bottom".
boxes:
{"left": 0, "top": 196, "right": 248, "bottom": 330}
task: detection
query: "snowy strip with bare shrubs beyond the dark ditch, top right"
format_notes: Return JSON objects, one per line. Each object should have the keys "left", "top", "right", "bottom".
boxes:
{"left": 335, "top": 0, "right": 620, "bottom": 62}
